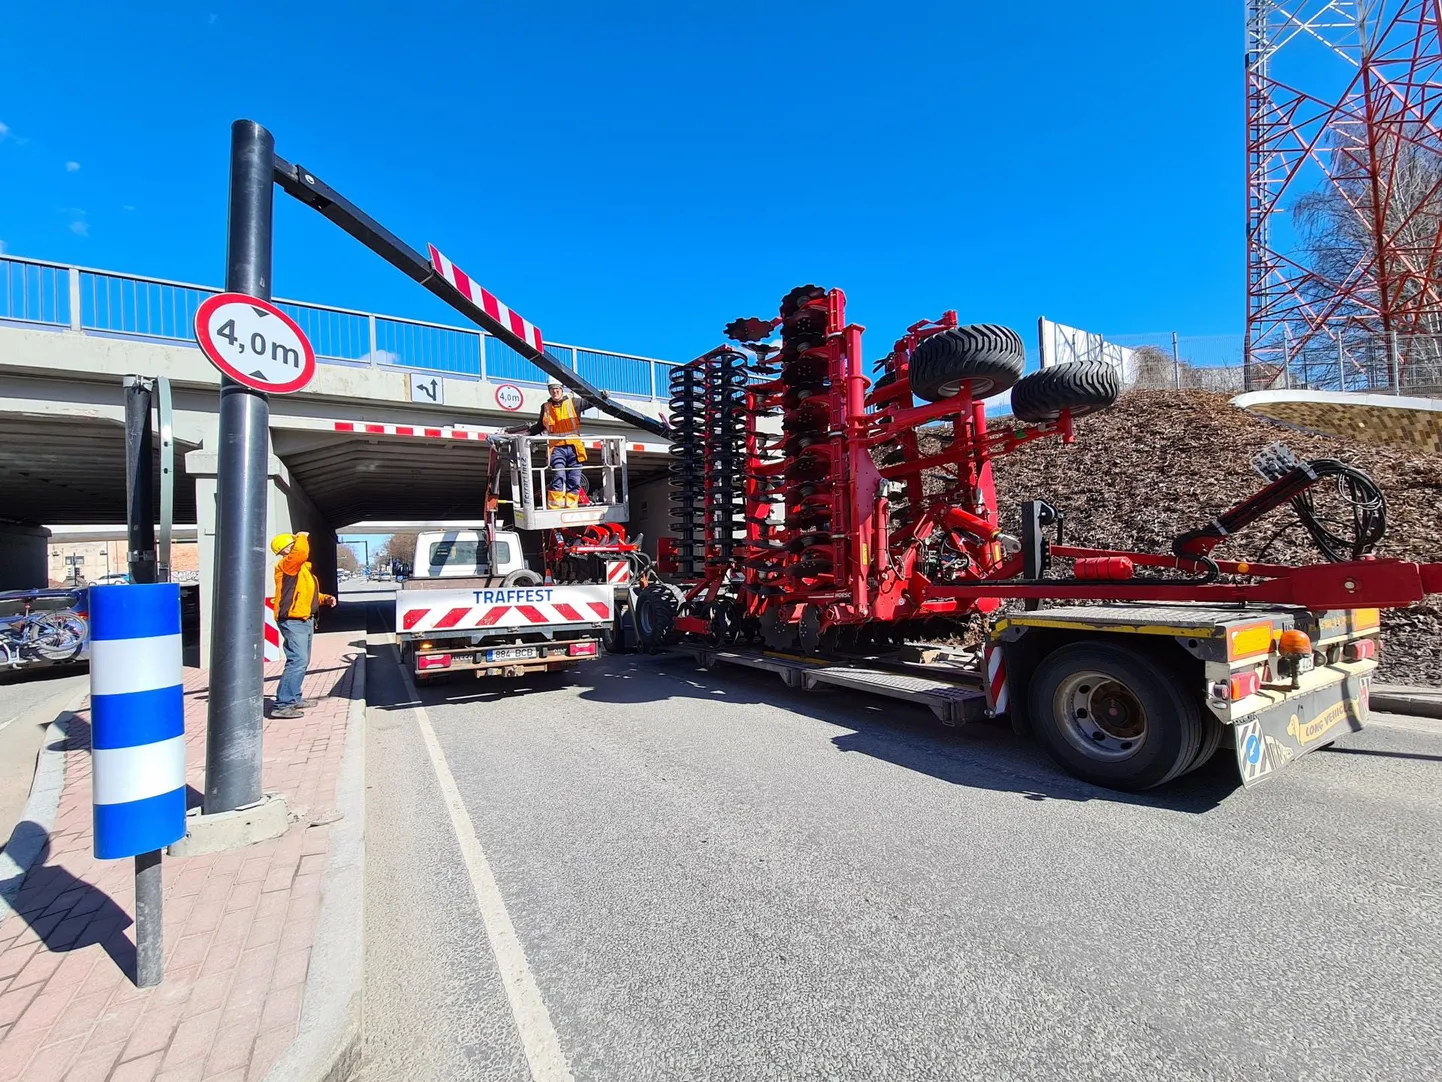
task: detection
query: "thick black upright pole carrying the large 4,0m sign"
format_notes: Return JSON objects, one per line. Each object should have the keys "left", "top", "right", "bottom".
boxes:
{"left": 203, "top": 120, "right": 275, "bottom": 815}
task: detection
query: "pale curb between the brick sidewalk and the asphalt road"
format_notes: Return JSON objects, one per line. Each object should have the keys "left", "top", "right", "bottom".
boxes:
{"left": 265, "top": 651, "right": 366, "bottom": 1082}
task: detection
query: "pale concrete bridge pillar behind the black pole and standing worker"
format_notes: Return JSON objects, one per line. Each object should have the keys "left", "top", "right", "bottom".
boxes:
{"left": 185, "top": 447, "right": 336, "bottom": 665}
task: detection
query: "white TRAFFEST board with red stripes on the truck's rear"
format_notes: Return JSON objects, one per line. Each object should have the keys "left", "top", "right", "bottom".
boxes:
{"left": 395, "top": 586, "right": 616, "bottom": 633}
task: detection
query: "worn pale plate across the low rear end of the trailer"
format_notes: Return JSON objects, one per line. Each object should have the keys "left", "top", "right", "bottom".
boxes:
{"left": 1234, "top": 674, "right": 1370, "bottom": 786}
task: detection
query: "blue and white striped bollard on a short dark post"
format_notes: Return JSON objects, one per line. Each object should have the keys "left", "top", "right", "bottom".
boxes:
{"left": 89, "top": 583, "right": 186, "bottom": 988}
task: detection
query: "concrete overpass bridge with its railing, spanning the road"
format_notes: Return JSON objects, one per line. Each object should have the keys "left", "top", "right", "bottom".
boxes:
{"left": 0, "top": 257, "right": 672, "bottom": 656}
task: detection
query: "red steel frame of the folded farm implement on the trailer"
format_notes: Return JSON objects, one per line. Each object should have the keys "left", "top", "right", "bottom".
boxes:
{"left": 660, "top": 287, "right": 1442, "bottom": 651}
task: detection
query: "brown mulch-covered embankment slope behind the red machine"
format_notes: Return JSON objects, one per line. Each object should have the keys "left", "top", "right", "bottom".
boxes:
{"left": 923, "top": 391, "right": 1442, "bottom": 685}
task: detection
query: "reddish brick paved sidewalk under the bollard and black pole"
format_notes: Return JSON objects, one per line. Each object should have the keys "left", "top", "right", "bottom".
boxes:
{"left": 0, "top": 632, "right": 365, "bottom": 1082}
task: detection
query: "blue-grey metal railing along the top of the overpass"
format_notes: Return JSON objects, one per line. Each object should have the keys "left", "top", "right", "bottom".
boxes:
{"left": 0, "top": 255, "right": 672, "bottom": 400}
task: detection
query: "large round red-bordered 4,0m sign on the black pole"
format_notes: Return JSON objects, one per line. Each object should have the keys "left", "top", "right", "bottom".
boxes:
{"left": 195, "top": 293, "right": 316, "bottom": 394}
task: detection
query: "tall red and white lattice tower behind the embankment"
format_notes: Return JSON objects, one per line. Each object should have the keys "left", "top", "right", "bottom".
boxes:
{"left": 1246, "top": 0, "right": 1442, "bottom": 388}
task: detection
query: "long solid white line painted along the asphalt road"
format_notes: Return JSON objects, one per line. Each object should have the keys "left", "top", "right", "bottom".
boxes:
{"left": 401, "top": 668, "right": 572, "bottom": 1082}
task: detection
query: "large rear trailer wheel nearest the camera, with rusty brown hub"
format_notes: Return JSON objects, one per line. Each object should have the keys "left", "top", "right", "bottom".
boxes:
{"left": 1027, "top": 642, "right": 1204, "bottom": 792}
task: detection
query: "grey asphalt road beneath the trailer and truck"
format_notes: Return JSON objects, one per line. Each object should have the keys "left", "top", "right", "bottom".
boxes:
{"left": 358, "top": 605, "right": 1442, "bottom": 1082}
